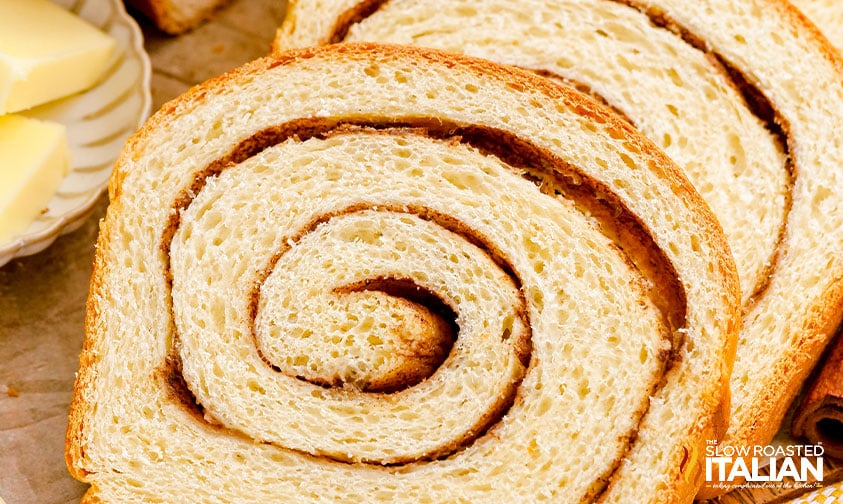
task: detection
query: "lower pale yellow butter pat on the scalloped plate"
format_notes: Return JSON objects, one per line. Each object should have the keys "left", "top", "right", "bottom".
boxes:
{"left": 0, "top": 115, "right": 70, "bottom": 244}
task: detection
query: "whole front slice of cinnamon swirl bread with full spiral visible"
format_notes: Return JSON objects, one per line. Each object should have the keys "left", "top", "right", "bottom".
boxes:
{"left": 67, "top": 44, "right": 740, "bottom": 503}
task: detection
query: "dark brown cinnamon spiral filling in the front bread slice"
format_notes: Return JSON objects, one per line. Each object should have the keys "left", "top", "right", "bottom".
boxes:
{"left": 160, "top": 117, "right": 686, "bottom": 472}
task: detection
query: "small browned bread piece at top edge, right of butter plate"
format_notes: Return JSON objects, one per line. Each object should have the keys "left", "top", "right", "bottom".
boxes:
{"left": 128, "top": 0, "right": 231, "bottom": 35}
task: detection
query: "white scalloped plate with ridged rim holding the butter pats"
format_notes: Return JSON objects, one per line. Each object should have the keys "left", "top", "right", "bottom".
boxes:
{"left": 0, "top": 0, "right": 152, "bottom": 266}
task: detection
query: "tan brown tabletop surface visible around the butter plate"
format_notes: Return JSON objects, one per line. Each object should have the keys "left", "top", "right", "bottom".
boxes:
{"left": 0, "top": 0, "right": 286, "bottom": 504}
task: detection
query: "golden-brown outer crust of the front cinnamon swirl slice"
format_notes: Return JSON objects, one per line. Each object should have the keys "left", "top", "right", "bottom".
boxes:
{"left": 66, "top": 43, "right": 740, "bottom": 502}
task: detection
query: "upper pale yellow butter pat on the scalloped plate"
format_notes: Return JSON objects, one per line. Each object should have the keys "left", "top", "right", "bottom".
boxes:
{"left": 0, "top": 0, "right": 116, "bottom": 114}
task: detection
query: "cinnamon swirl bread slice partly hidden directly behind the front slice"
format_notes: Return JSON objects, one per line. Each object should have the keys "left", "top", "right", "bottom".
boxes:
{"left": 275, "top": 0, "right": 843, "bottom": 496}
